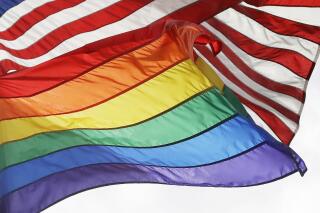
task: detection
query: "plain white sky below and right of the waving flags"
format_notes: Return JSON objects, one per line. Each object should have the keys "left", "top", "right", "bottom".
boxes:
{"left": 44, "top": 6, "right": 320, "bottom": 213}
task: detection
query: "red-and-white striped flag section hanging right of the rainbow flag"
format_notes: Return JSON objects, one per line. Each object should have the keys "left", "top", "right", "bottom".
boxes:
{"left": 195, "top": 1, "right": 320, "bottom": 144}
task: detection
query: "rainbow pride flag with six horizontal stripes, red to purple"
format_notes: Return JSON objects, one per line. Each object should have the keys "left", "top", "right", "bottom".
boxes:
{"left": 0, "top": 21, "right": 306, "bottom": 213}
